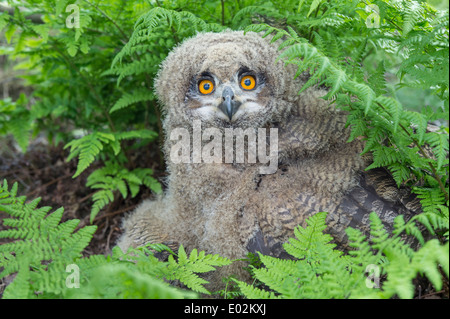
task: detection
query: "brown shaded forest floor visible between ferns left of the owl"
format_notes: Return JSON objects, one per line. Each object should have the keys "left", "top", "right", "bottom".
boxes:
{"left": 0, "top": 137, "right": 165, "bottom": 298}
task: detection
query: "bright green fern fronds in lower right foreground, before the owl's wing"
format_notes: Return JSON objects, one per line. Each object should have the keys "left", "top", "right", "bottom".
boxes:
{"left": 237, "top": 213, "right": 449, "bottom": 299}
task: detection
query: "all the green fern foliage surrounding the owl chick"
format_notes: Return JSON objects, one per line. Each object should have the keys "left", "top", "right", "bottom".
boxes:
{"left": 0, "top": 0, "right": 449, "bottom": 298}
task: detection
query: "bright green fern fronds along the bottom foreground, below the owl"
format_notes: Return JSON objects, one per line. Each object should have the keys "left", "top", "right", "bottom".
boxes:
{"left": 0, "top": 181, "right": 449, "bottom": 298}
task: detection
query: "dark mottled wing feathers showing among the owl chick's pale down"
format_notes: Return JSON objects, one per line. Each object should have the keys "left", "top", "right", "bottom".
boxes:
{"left": 247, "top": 168, "right": 421, "bottom": 258}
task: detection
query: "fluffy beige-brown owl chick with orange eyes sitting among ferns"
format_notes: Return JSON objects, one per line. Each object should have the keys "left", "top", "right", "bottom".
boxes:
{"left": 118, "top": 31, "right": 417, "bottom": 284}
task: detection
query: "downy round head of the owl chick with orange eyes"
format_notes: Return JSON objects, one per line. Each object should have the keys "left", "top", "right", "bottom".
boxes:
{"left": 155, "top": 31, "right": 300, "bottom": 128}
